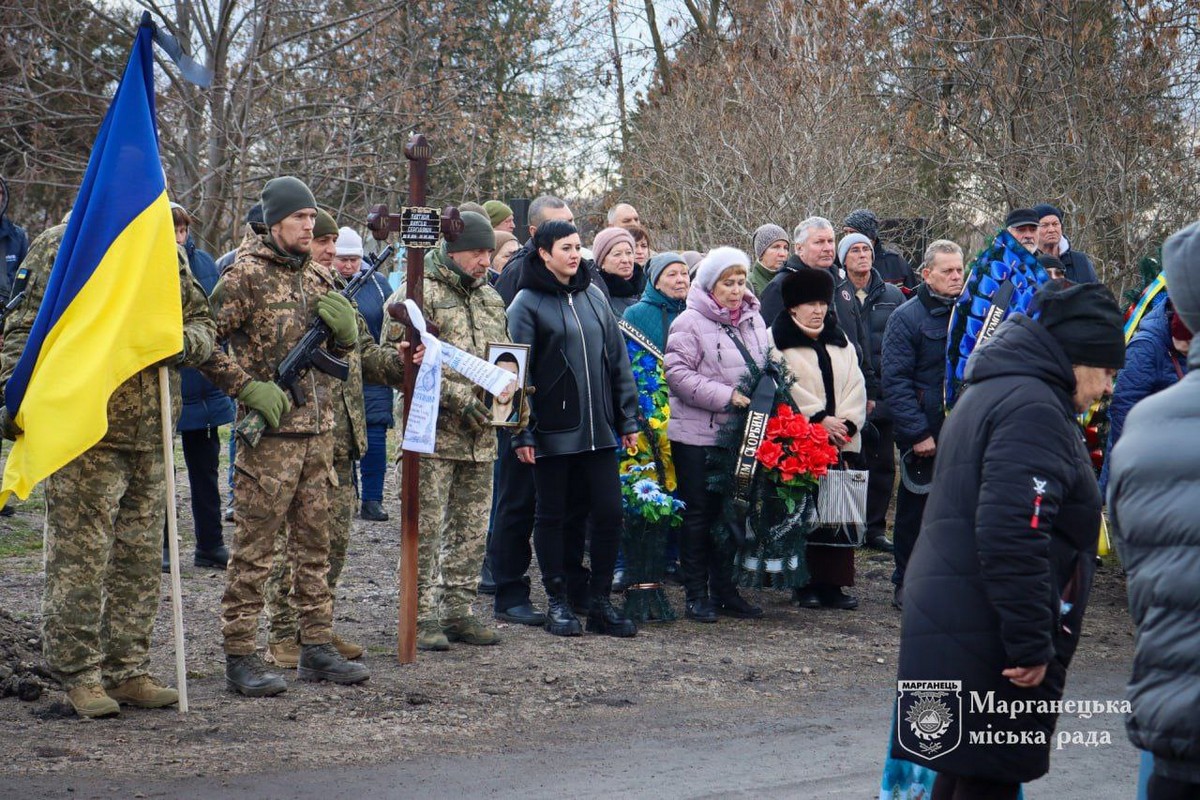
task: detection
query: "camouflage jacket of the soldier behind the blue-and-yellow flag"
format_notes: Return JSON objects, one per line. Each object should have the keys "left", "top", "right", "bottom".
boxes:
{"left": 0, "top": 225, "right": 216, "bottom": 450}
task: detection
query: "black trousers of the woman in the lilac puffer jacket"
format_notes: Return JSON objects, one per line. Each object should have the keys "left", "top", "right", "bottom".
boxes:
{"left": 671, "top": 441, "right": 737, "bottom": 601}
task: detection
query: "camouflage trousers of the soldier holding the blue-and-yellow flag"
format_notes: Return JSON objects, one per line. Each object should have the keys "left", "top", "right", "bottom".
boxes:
{"left": 42, "top": 444, "right": 167, "bottom": 690}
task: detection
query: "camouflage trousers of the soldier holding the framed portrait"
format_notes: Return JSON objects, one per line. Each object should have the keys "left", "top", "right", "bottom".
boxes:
{"left": 416, "top": 458, "right": 492, "bottom": 622}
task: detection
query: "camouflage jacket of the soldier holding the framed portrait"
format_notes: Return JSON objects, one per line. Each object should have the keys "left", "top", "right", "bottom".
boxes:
{"left": 384, "top": 245, "right": 509, "bottom": 462}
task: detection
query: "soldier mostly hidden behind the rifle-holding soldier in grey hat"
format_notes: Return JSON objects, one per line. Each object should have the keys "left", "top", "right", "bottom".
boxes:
{"left": 265, "top": 210, "right": 403, "bottom": 669}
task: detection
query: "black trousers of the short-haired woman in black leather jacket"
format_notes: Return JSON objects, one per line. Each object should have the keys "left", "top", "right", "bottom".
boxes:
{"left": 533, "top": 449, "right": 625, "bottom": 601}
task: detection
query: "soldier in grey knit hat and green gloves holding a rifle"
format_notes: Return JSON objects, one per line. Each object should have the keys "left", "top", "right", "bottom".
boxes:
{"left": 204, "top": 178, "right": 401, "bottom": 697}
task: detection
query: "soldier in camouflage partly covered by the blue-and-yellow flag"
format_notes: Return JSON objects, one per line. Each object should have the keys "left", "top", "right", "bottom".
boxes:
{"left": 0, "top": 224, "right": 216, "bottom": 717}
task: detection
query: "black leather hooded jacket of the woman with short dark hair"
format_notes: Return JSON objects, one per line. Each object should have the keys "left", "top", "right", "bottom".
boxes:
{"left": 505, "top": 253, "right": 637, "bottom": 457}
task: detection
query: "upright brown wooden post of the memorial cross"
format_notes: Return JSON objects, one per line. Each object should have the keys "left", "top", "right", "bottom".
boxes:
{"left": 396, "top": 133, "right": 431, "bottom": 664}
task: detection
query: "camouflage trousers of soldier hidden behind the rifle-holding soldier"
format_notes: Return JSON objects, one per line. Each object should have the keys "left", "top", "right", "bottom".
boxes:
{"left": 265, "top": 452, "right": 354, "bottom": 643}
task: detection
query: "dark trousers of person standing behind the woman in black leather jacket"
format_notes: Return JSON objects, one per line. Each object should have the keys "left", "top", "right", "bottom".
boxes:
{"left": 487, "top": 429, "right": 590, "bottom": 612}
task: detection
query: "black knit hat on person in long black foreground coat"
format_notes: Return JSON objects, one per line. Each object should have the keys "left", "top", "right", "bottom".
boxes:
{"left": 1030, "top": 281, "right": 1124, "bottom": 369}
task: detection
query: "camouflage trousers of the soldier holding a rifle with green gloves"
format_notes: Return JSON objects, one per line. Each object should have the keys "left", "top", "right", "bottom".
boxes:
{"left": 221, "top": 433, "right": 337, "bottom": 656}
